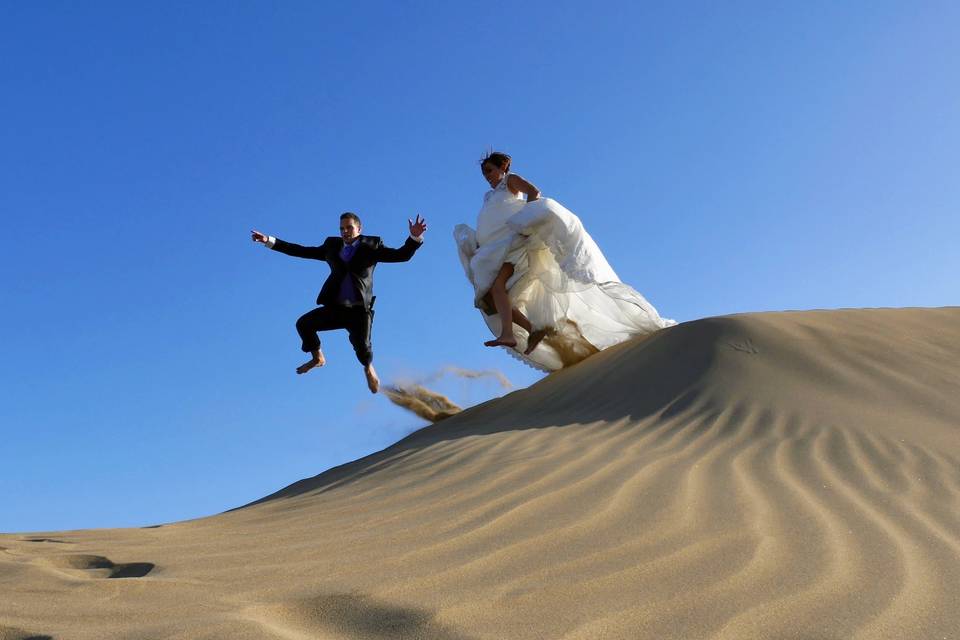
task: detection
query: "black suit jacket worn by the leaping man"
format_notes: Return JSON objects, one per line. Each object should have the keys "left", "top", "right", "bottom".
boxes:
{"left": 273, "top": 235, "right": 422, "bottom": 309}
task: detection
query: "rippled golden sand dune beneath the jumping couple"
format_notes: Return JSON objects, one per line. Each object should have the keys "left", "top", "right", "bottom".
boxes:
{"left": 0, "top": 308, "right": 960, "bottom": 640}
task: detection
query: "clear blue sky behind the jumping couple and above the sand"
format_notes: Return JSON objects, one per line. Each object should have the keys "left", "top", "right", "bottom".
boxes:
{"left": 0, "top": 1, "right": 960, "bottom": 531}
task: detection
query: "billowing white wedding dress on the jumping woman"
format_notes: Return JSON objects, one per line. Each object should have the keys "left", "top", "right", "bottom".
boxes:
{"left": 453, "top": 176, "right": 676, "bottom": 371}
